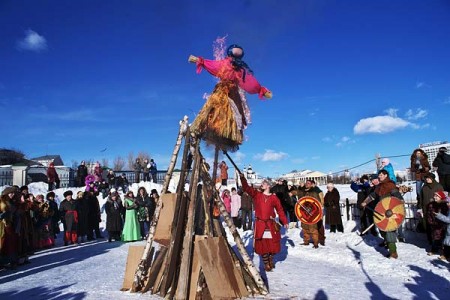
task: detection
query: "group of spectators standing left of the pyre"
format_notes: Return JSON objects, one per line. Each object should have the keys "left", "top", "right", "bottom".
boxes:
{"left": 0, "top": 175, "right": 159, "bottom": 269}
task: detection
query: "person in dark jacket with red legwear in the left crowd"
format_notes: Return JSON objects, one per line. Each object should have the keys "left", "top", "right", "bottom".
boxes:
{"left": 59, "top": 191, "right": 78, "bottom": 246}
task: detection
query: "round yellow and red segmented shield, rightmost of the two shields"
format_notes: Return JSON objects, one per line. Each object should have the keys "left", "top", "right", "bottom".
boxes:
{"left": 373, "top": 196, "right": 405, "bottom": 231}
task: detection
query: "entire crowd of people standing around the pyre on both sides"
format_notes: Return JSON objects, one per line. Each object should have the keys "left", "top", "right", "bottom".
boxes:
{"left": 0, "top": 148, "right": 450, "bottom": 271}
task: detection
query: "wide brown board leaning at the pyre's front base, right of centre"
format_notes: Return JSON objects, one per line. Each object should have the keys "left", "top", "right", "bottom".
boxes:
{"left": 195, "top": 237, "right": 248, "bottom": 299}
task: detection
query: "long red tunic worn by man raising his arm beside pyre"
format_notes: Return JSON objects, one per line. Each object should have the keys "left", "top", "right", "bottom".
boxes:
{"left": 241, "top": 177, "right": 288, "bottom": 254}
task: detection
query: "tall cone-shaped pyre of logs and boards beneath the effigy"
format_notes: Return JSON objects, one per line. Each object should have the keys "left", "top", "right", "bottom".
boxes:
{"left": 122, "top": 117, "right": 268, "bottom": 299}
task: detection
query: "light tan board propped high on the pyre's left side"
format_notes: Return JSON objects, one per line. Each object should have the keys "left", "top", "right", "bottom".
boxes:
{"left": 154, "top": 194, "right": 177, "bottom": 247}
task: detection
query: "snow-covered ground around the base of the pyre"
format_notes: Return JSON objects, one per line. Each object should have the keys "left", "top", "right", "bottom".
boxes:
{"left": 0, "top": 184, "right": 450, "bottom": 299}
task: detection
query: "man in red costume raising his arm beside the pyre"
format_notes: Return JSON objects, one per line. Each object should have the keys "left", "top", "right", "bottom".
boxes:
{"left": 239, "top": 173, "right": 288, "bottom": 271}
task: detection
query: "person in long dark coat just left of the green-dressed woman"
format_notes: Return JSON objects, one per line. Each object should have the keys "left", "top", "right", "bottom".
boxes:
{"left": 105, "top": 191, "right": 124, "bottom": 242}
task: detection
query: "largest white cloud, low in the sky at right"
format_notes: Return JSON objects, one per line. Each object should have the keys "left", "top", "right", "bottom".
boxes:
{"left": 353, "top": 115, "right": 412, "bottom": 134}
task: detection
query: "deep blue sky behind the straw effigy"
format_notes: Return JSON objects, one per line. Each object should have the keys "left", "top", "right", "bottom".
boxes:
{"left": 0, "top": 0, "right": 450, "bottom": 176}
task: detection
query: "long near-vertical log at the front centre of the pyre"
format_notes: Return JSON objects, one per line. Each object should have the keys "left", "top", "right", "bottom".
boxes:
{"left": 174, "top": 138, "right": 201, "bottom": 299}
